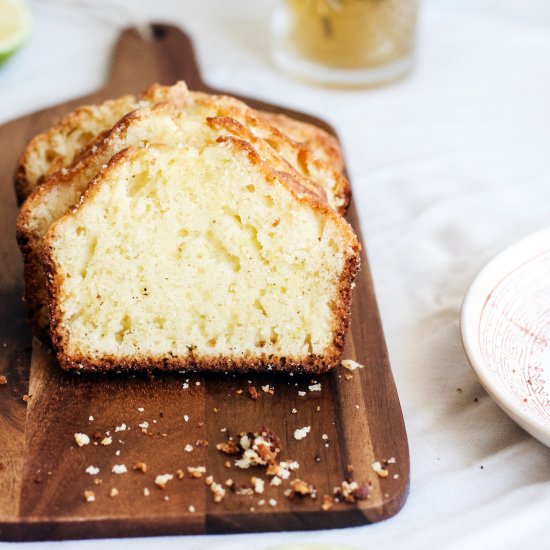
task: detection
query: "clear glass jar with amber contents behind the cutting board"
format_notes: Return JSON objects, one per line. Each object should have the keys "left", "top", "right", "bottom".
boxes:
{"left": 272, "top": 0, "right": 419, "bottom": 86}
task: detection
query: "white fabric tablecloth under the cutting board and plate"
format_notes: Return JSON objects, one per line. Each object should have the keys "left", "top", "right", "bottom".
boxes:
{"left": 0, "top": 0, "right": 550, "bottom": 550}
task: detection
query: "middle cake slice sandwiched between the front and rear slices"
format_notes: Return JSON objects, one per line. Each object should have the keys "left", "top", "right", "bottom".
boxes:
{"left": 17, "top": 101, "right": 349, "bottom": 340}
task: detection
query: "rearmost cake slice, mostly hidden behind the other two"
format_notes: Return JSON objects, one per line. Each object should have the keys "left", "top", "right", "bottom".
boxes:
{"left": 14, "top": 82, "right": 342, "bottom": 203}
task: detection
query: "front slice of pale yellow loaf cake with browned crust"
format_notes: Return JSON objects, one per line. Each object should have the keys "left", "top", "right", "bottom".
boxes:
{"left": 43, "top": 142, "right": 359, "bottom": 372}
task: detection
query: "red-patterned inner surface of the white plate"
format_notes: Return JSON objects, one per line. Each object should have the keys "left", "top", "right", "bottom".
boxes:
{"left": 478, "top": 250, "right": 550, "bottom": 421}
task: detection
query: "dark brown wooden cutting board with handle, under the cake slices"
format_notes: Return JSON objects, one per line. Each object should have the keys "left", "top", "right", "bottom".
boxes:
{"left": 0, "top": 25, "right": 409, "bottom": 540}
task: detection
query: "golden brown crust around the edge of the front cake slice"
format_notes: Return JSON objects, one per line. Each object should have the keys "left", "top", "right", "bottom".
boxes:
{"left": 41, "top": 142, "right": 361, "bottom": 373}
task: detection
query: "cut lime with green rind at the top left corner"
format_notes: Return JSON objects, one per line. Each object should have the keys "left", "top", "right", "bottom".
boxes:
{"left": 0, "top": 0, "right": 31, "bottom": 64}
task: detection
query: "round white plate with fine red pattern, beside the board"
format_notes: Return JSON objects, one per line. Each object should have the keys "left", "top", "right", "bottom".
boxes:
{"left": 460, "top": 229, "right": 550, "bottom": 446}
